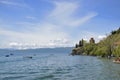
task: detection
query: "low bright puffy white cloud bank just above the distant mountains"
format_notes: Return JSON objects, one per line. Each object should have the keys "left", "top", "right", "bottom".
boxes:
{"left": 8, "top": 33, "right": 71, "bottom": 49}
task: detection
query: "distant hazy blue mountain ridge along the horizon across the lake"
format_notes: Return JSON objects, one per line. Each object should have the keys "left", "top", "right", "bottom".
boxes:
{"left": 0, "top": 47, "right": 73, "bottom": 54}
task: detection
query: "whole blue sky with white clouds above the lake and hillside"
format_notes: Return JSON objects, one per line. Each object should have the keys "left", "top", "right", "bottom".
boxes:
{"left": 0, "top": 0, "right": 120, "bottom": 48}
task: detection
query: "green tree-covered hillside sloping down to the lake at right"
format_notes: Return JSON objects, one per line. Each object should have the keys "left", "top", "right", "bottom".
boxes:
{"left": 71, "top": 28, "right": 120, "bottom": 57}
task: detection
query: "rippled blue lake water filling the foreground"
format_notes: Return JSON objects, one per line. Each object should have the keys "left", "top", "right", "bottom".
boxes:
{"left": 0, "top": 49, "right": 120, "bottom": 80}
